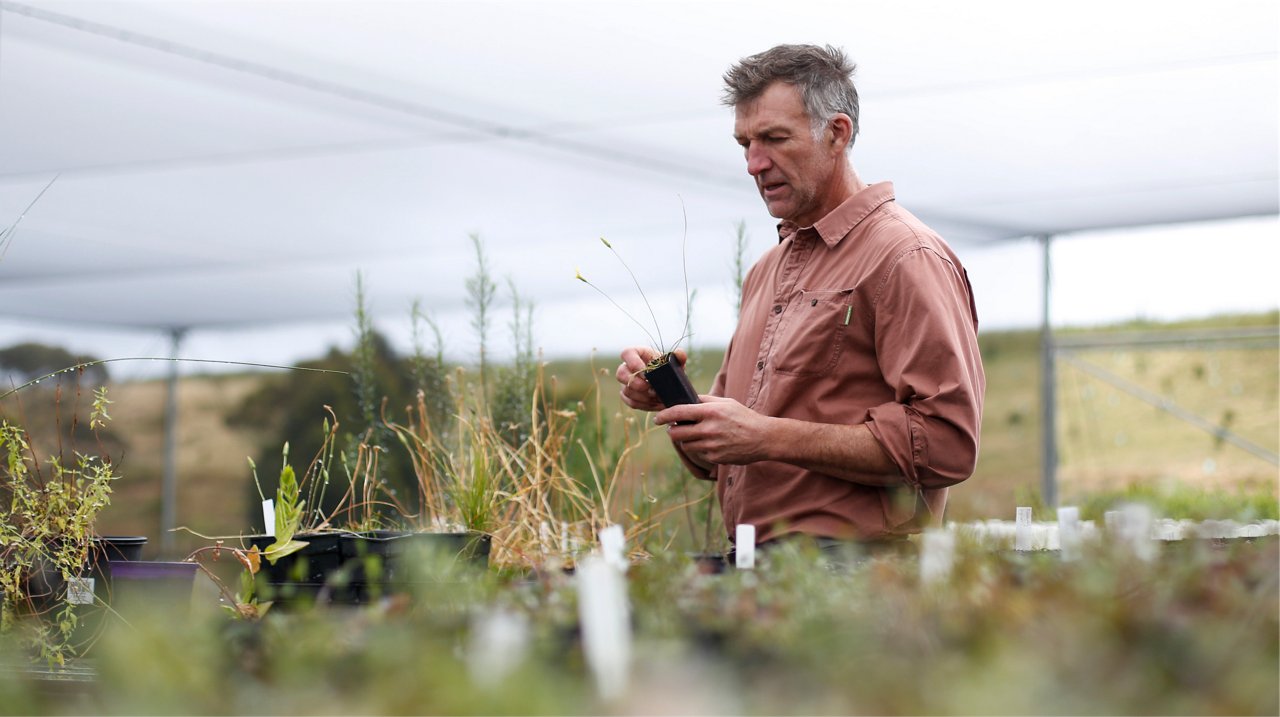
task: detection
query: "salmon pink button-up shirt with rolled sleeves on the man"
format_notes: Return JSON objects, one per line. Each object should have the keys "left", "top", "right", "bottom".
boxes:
{"left": 690, "top": 182, "right": 986, "bottom": 542}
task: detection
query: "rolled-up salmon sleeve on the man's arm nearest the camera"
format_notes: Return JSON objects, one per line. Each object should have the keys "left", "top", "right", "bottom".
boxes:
{"left": 867, "top": 247, "right": 986, "bottom": 489}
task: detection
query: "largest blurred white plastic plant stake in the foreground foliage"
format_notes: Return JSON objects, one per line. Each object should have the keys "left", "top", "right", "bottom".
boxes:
{"left": 577, "top": 556, "right": 631, "bottom": 699}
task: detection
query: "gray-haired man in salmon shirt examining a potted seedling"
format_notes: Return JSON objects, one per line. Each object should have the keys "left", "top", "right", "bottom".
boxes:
{"left": 617, "top": 45, "right": 986, "bottom": 543}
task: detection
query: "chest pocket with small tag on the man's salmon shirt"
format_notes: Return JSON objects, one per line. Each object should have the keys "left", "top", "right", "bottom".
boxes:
{"left": 773, "top": 289, "right": 854, "bottom": 376}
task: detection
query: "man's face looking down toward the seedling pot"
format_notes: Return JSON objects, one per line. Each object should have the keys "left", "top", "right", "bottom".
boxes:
{"left": 733, "top": 82, "right": 844, "bottom": 227}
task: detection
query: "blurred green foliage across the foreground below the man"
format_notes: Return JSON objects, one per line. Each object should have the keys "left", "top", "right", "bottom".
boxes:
{"left": 0, "top": 536, "right": 1280, "bottom": 714}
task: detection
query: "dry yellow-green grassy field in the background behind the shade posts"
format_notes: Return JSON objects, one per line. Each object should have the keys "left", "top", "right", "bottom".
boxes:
{"left": 17, "top": 314, "right": 1280, "bottom": 551}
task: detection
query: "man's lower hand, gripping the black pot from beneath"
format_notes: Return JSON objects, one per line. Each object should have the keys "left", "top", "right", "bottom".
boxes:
{"left": 653, "top": 396, "right": 777, "bottom": 466}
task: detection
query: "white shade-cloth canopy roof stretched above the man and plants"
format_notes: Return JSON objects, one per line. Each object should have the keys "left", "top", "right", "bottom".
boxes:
{"left": 0, "top": 0, "right": 1280, "bottom": 361}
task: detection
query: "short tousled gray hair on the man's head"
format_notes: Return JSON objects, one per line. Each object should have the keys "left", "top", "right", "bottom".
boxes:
{"left": 721, "top": 45, "right": 858, "bottom": 149}
